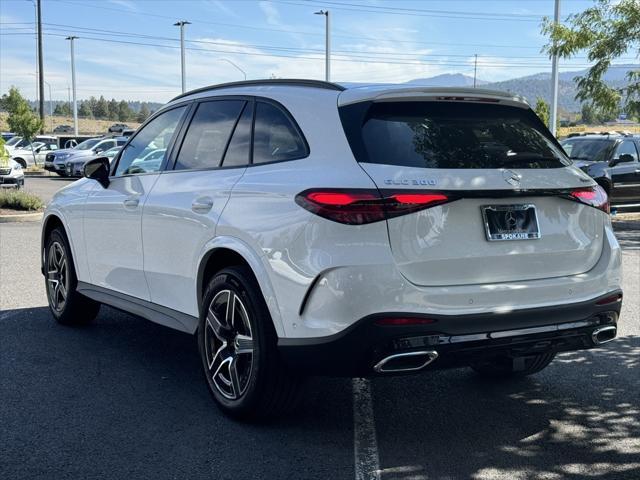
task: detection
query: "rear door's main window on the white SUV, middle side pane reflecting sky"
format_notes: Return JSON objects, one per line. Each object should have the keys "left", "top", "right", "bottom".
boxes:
{"left": 175, "top": 100, "right": 245, "bottom": 170}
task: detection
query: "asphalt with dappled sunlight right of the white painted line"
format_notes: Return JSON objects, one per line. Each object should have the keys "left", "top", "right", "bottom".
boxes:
{"left": 374, "top": 336, "right": 640, "bottom": 480}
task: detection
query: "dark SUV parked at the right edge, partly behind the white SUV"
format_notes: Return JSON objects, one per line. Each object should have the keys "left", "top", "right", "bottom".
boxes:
{"left": 560, "top": 135, "right": 640, "bottom": 204}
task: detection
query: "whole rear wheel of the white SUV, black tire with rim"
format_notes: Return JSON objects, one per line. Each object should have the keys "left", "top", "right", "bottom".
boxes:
{"left": 198, "top": 266, "right": 300, "bottom": 420}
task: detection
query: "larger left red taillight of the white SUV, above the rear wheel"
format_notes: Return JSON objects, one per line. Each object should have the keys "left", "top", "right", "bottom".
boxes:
{"left": 296, "top": 189, "right": 454, "bottom": 225}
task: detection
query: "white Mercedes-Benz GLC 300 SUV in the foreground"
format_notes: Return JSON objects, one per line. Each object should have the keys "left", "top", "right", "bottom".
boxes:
{"left": 42, "top": 80, "right": 622, "bottom": 418}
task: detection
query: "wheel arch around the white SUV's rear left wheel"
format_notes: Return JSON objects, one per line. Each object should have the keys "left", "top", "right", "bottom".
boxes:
{"left": 196, "top": 237, "right": 284, "bottom": 337}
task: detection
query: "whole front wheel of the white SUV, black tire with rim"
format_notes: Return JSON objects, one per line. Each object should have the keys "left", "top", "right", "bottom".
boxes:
{"left": 44, "top": 228, "right": 100, "bottom": 325}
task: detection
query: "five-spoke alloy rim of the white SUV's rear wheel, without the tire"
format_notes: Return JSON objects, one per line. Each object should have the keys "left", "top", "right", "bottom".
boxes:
{"left": 204, "top": 290, "right": 254, "bottom": 400}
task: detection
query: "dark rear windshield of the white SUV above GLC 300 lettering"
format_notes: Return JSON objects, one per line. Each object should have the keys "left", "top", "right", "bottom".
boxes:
{"left": 340, "top": 101, "right": 569, "bottom": 169}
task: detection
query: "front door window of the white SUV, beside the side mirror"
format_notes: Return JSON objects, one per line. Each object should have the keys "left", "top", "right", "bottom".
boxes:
{"left": 115, "top": 107, "right": 186, "bottom": 176}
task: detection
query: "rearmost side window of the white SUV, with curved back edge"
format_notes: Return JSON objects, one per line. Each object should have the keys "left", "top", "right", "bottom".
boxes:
{"left": 253, "top": 102, "right": 307, "bottom": 163}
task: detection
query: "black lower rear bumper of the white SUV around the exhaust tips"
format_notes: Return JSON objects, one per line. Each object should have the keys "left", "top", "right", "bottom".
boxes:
{"left": 278, "top": 291, "right": 622, "bottom": 377}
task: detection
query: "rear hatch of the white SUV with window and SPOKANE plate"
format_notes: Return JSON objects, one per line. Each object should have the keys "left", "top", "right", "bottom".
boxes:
{"left": 340, "top": 91, "right": 606, "bottom": 286}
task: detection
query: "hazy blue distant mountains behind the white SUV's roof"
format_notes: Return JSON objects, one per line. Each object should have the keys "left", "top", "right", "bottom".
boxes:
{"left": 407, "top": 65, "right": 640, "bottom": 112}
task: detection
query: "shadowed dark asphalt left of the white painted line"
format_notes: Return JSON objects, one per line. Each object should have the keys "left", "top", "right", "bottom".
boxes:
{"left": 0, "top": 307, "right": 353, "bottom": 479}
